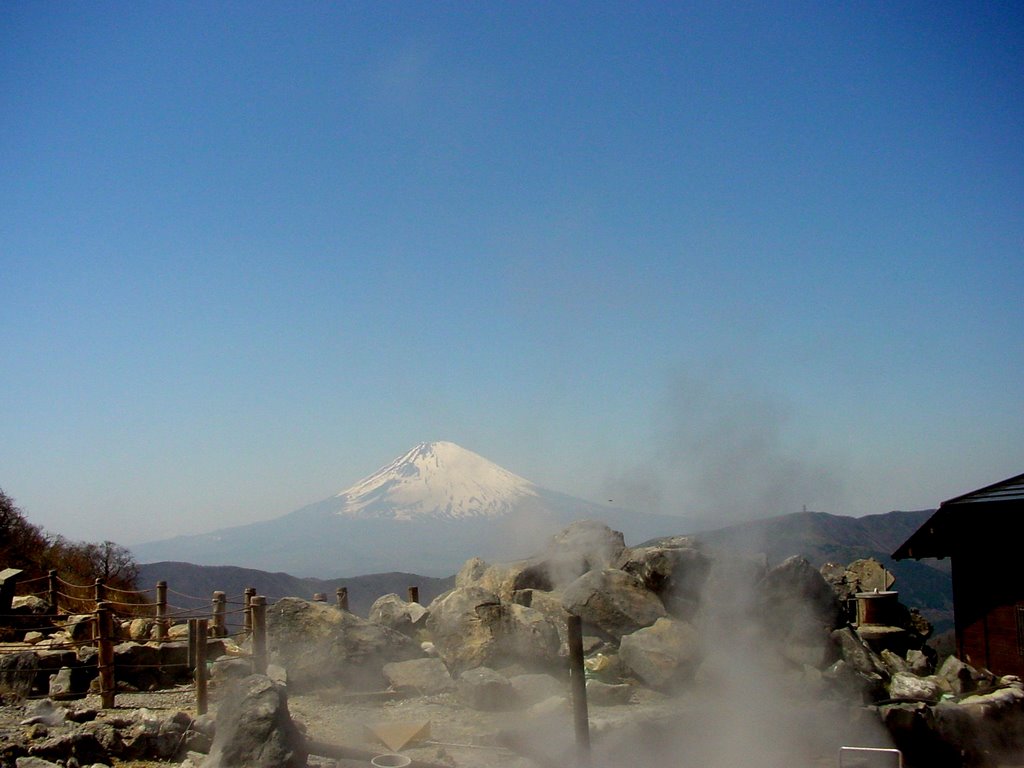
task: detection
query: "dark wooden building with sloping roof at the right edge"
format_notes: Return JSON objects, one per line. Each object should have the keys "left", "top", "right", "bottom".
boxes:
{"left": 893, "top": 474, "right": 1024, "bottom": 677}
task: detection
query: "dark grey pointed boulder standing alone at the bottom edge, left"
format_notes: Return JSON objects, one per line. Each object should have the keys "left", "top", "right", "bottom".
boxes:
{"left": 203, "top": 675, "right": 306, "bottom": 768}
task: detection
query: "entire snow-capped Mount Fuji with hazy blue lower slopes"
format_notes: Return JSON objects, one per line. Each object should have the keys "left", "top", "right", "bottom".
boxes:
{"left": 131, "top": 442, "right": 683, "bottom": 578}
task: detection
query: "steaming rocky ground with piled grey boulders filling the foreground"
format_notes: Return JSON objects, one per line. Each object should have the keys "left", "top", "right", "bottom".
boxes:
{"left": 8, "top": 522, "right": 1024, "bottom": 768}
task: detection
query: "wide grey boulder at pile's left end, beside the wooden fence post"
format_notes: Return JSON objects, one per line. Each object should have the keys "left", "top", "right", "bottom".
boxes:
{"left": 266, "top": 597, "right": 423, "bottom": 689}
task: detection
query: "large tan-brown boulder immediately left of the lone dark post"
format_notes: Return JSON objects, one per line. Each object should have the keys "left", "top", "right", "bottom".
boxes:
{"left": 427, "top": 586, "right": 559, "bottom": 675}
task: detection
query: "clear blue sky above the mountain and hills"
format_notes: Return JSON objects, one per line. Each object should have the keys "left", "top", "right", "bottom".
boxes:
{"left": 0, "top": 2, "right": 1024, "bottom": 544}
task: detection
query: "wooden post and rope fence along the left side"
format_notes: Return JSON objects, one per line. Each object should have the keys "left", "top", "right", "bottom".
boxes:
{"left": 0, "top": 569, "right": 419, "bottom": 714}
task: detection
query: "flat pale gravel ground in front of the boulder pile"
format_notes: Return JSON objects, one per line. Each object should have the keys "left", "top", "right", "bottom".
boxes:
{"left": 0, "top": 687, "right": 836, "bottom": 768}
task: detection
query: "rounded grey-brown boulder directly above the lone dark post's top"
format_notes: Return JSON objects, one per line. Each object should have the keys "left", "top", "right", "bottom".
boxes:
{"left": 562, "top": 568, "right": 666, "bottom": 639}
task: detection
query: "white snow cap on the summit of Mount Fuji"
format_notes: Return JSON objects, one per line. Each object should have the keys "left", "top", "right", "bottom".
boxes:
{"left": 337, "top": 441, "right": 538, "bottom": 520}
